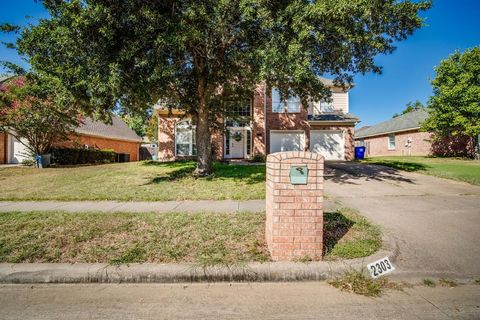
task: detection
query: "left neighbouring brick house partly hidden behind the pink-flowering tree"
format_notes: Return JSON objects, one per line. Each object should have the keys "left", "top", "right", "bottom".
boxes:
{"left": 0, "top": 116, "right": 142, "bottom": 164}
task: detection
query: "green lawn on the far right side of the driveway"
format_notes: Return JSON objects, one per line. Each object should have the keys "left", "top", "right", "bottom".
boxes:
{"left": 363, "top": 157, "right": 480, "bottom": 185}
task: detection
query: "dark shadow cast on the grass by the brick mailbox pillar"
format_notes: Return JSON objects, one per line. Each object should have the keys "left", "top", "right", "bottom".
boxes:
{"left": 323, "top": 211, "right": 355, "bottom": 255}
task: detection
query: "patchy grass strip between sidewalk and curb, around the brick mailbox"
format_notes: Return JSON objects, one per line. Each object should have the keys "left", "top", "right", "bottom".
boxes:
{"left": 0, "top": 208, "right": 381, "bottom": 266}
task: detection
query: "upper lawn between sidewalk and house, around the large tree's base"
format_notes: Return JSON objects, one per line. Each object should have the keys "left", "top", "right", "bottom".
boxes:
{"left": 0, "top": 161, "right": 265, "bottom": 201}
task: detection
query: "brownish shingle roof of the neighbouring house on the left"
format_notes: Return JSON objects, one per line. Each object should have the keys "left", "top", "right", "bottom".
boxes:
{"left": 75, "top": 116, "right": 142, "bottom": 142}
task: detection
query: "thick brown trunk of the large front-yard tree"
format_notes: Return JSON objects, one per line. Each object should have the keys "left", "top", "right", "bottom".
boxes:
{"left": 194, "top": 92, "right": 212, "bottom": 176}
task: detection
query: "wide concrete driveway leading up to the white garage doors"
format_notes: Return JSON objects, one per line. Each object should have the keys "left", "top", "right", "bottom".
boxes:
{"left": 325, "top": 162, "right": 480, "bottom": 278}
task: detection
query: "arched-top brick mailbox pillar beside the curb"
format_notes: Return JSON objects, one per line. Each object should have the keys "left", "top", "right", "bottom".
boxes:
{"left": 265, "top": 151, "right": 324, "bottom": 261}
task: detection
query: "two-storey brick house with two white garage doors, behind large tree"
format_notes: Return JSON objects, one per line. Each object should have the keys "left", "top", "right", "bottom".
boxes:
{"left": 156, "top": 79, "right": 359, "bottom": 161}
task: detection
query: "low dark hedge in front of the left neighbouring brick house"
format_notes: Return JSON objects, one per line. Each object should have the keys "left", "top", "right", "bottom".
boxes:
{"left": 51, "top": 148, "right": 116, "bottom": 165}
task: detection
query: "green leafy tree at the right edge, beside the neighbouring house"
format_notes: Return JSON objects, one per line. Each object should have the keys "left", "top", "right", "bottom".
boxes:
{"left": 423, "top": 47, "right": 480, "bottom": 154}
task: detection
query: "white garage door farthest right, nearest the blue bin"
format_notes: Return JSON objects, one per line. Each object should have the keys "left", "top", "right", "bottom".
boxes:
{"left": 310, "top": 130, "right": 345, "bottom": 160}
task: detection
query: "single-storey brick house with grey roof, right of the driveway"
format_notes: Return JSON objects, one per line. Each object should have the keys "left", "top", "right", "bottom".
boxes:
{"left": 355, "top": 110, "right": 432, "bottom": 157}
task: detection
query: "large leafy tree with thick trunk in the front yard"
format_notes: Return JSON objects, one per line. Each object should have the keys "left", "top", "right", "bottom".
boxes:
{"left": 18, "top": 0, "right": 430, "bottom": 174}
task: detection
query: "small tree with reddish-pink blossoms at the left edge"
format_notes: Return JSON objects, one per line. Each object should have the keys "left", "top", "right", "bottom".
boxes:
{"left": 0, "top": 74, "right": 82, "bottom": 155}
